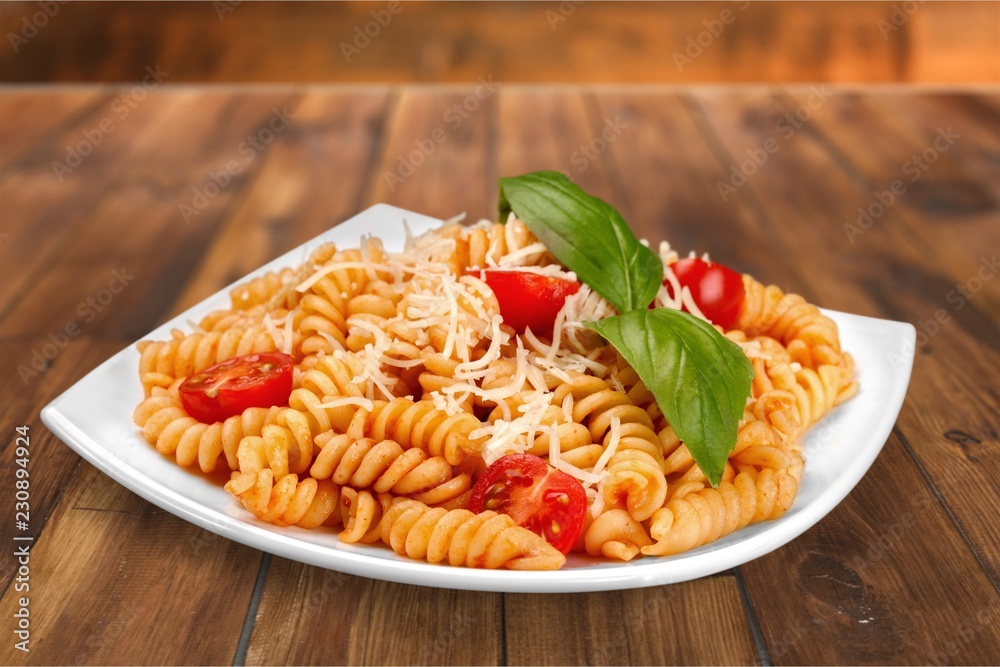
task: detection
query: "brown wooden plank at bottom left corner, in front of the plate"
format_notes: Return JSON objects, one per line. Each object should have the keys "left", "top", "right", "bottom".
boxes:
{"left": 0, "top": 463, "right": 261, "bottom": 665}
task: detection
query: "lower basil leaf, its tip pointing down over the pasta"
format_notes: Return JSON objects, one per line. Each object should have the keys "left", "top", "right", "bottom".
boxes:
{"left": 587, "top": 308, "right": 753, "bottom": 486}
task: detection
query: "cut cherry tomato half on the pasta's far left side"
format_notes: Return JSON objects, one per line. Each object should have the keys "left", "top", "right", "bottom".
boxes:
{"left": 179, "top": 352, "right": 293, "bottom": 424}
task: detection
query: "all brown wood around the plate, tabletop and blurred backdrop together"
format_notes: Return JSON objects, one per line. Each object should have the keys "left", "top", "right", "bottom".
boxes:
{"left": 0, "top": 2, "right": 1000, "bottom": 665}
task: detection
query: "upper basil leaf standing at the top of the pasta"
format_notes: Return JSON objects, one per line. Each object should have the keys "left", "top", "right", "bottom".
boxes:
{"left": 499, "top": 171, "right": 663, "bottom": 313}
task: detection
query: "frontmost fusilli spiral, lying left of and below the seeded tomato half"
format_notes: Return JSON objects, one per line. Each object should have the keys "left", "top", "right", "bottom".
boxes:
{"left": 381, "top": 500, "right": 566, "bottom": 570}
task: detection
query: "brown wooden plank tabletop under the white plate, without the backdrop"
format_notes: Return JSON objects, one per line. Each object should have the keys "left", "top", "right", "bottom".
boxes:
{"left": 0, "top": 85, "right": 1000, "bottom": 664}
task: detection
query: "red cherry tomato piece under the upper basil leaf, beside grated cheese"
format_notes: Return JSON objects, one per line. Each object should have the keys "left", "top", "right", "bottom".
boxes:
{"left": 471, "top": 269, "right": 580, "bottom": 336}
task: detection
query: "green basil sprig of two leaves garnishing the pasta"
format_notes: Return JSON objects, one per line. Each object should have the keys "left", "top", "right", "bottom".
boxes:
{"left": 500, "top": 171, "right": 753, "bottom": 486}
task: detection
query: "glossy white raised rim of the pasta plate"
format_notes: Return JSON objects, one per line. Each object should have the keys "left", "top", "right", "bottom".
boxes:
{"left": 41, "top": 204, "right": 916, "bottom": 593}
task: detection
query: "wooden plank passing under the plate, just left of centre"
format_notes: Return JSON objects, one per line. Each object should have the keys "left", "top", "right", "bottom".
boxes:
{"left": 247, "top": 89, "right": 502, "bottom": 664}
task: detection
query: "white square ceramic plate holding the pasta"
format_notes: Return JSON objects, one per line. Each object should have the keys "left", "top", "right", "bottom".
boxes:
{"left": 42, "top": 204, "right": 915, "bottom": 593}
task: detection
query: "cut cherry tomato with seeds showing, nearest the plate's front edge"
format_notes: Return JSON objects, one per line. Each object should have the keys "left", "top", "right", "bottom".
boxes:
{"left": 469, "top": 454, "right": 587, "bottom": 554}
